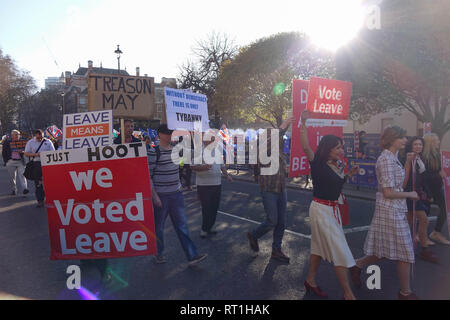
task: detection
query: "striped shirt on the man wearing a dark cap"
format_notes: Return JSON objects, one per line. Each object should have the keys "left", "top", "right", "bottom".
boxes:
{"left": 147, "top": 146, "right": 181, "bottom": 194}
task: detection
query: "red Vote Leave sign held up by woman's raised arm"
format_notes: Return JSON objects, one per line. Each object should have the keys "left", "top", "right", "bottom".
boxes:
{"left": 307, "top": 77, "right": 353, "bottom": 127}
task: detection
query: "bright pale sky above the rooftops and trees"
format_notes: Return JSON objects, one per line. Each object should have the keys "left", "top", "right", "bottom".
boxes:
{"left": 0, "top": 0, "right": 372, "bottom": 87}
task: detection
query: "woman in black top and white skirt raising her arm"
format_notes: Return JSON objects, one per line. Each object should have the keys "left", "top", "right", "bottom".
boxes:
{"left": 300, "top": 111, "right": 359, "bottom": 300}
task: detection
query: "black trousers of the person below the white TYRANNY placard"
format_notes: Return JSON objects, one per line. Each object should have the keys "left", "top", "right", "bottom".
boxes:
{"left": 197, "top": 185, "right": 222, "bottom": 232}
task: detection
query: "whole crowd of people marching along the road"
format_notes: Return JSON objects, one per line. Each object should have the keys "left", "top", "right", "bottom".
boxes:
{"left": 2, "top": 111, "right": 450, "bottom": 300}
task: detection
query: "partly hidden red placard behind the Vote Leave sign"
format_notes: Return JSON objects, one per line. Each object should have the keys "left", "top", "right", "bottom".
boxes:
{"left": 289, "top": 80, "right": 344, "bottom": 178}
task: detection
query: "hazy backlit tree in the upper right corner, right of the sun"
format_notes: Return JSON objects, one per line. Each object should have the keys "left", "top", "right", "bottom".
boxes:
{"left": 338, "top": 0, "right": 450, "bottom": 137}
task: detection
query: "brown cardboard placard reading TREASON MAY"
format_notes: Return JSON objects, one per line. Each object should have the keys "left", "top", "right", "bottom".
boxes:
{"left": 88, "top": 74, "right": 155, "bottom": 120}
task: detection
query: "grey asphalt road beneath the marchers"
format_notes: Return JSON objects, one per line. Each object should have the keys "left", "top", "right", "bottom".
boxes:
{"left": 0, "top": 168, "right": 450, "bottom": 300}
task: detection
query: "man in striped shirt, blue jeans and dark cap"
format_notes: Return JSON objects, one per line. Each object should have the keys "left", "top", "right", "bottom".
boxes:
{"left": 147, "top": 124, "right": 207, "bottom": 265}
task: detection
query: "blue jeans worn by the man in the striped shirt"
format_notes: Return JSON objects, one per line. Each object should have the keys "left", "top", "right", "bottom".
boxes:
{"left": 154, "top": 191, "right": 198, "bottom": 261}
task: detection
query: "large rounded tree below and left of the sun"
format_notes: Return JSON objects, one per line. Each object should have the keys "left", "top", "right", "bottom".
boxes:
{"left": 213, "top": 32, "right": 335, "bottom": 127}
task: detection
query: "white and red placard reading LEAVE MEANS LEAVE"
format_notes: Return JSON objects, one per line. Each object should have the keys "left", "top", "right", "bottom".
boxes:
{"left": 63, "top": 110, "right": 113, "bottom": 150}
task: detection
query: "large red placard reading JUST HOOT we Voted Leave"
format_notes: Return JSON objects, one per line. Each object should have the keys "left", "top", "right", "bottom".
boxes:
{"left": 41, "top": 143, "right": 156, "bottom": 260}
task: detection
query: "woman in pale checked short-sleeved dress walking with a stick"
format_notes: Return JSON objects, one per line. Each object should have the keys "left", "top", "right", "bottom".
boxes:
{"left": 351, "top": 126, "right": 419, "bottom": 300}
